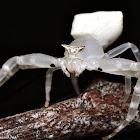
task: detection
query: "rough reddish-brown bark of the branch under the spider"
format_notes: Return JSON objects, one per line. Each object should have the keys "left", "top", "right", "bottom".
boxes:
{"left": 0, "top": 80, "right": 140, "bottom": 140}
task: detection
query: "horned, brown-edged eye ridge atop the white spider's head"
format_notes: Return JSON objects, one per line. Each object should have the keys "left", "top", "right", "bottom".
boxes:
{"left": 62, "top": 44, "right": 85, "bottom": 58}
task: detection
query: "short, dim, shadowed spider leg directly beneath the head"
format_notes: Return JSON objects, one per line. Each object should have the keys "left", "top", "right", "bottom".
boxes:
{"left": 71, "top": 74, "right": 80, "bottom": 95}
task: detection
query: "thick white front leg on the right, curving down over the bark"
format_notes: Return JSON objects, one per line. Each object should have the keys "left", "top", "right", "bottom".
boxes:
{"left": 98, "top": 58, "right": 140, "bottom": 140}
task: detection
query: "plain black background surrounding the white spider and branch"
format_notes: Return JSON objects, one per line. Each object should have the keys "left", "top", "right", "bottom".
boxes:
{"left": 0, "top": 0, "right": 140, "bottom": 140}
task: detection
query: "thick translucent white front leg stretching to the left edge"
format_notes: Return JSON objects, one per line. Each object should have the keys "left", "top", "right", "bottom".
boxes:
{"left": 0, "top": 54, "right": 58, "bottom": 86}
